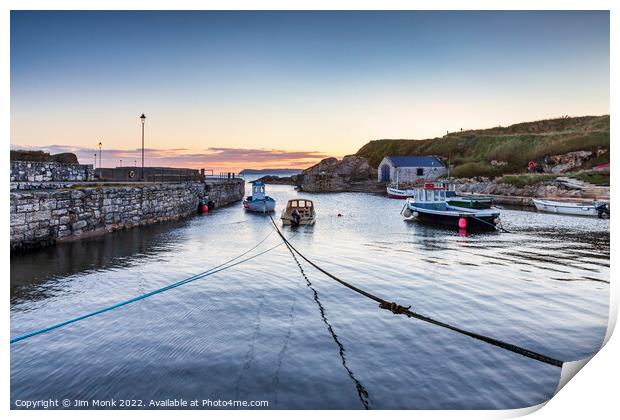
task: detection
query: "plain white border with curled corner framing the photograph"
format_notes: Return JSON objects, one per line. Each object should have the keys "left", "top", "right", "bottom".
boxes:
{"left": 0, "top": 0, "right": 620, "bottom": 419}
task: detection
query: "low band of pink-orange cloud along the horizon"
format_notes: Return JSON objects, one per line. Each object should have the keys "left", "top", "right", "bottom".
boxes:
{"left": 11, "top": 144, "right": 328, "bottom": 171}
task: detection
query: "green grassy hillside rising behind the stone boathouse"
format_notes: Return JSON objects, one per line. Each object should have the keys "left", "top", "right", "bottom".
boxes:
{"left": 357, "top": 115, "right": 609, "bottom": 177}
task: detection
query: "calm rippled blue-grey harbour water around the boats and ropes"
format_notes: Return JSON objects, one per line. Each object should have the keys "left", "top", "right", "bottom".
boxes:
{"left": 11, "top": 182, "right": 609, "bottom": 409}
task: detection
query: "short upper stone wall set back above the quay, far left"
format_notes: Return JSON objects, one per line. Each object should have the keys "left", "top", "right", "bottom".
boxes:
{"left": 11, "top": 160, "right": 95, "bottom": 182}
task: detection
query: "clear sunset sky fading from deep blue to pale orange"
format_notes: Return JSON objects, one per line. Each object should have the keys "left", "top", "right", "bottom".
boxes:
{"left": 10, "top": 11, "right": 610, "bottom": 172}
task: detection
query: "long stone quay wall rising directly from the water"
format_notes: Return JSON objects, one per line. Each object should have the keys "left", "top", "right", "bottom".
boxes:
{"left": 11, "top": 182, "right": 243, "bottom": 251}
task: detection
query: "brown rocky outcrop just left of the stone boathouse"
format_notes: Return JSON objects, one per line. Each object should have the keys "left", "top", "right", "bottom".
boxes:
{"left": 297, "top": 155, "right": 384, "bottom": 192}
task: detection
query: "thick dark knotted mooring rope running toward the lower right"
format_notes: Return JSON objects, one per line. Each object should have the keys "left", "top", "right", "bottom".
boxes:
{"left": 269, "top": 216, "right": 564, "bottom": 368}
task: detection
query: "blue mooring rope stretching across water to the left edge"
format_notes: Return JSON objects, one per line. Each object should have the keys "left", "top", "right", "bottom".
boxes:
{"left": 11, "top": 230, "right": 283, "bottom": 344}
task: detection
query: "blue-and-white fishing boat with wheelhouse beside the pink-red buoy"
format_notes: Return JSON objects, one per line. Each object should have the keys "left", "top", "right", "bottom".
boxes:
{"left": 401, "top": 183, "right": 500, "bottom": 229}
